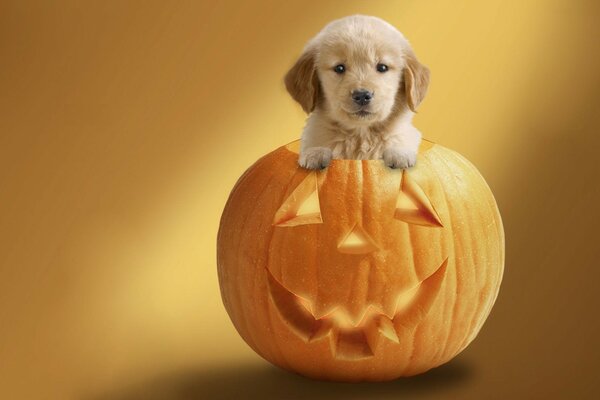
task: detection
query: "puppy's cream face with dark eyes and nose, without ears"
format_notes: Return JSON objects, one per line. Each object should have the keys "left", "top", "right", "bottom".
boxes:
{"left": 316, "top": 35, "right": 405, "bottom": 125}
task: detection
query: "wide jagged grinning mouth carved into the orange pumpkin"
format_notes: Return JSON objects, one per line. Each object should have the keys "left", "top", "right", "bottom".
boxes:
{"left": 267, "top": 258, "right": 448, "bottom": 360}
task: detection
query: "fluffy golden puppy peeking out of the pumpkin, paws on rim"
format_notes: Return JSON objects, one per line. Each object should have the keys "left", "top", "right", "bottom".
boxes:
{"left": 284, "top": 15, "right": 429, "bottom": 169}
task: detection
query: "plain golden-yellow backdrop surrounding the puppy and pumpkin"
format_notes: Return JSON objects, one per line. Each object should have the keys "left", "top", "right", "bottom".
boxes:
{"left": 0, "top": 0, "right": 600, "bottom": 399}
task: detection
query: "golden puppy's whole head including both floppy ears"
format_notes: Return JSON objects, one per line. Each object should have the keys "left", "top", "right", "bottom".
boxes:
{"left": 284, "top": 15, "right": 429, "bottom": 126}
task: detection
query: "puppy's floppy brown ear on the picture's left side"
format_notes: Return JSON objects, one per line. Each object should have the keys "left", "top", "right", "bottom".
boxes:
{"left": 284, "top": 47, "right": 320, "bottom": 114}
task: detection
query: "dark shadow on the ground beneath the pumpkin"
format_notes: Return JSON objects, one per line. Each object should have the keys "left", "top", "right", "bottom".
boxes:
{"left": 91, "top": 360, "right": 475, "bottom": 400}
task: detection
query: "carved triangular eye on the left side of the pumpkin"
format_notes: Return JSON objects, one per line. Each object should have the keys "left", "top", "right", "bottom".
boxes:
{"left": 273, "top": 171, "right": 323, "bottom": 226}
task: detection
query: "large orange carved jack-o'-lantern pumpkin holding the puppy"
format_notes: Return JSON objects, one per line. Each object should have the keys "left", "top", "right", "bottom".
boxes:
{"left": 217, "top": 140, "right": 504, "bottom": 381}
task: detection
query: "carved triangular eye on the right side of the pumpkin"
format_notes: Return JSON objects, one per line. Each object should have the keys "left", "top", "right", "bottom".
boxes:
{"left": 394, "top": 171, "right": 443, "bottom": 227}
